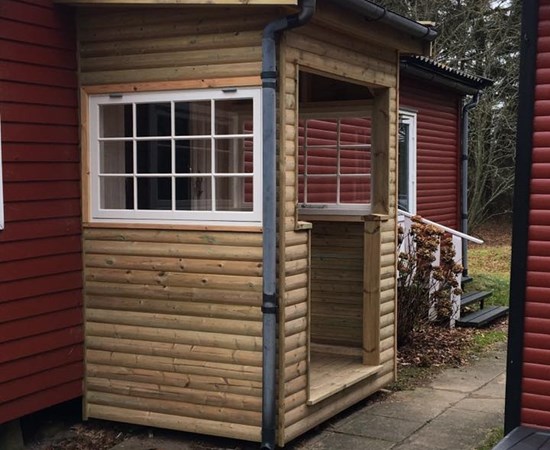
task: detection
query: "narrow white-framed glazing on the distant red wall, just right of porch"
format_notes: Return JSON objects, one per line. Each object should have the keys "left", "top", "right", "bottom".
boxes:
{"left": 398, "top": 111, "right": 416, "bottom": 214}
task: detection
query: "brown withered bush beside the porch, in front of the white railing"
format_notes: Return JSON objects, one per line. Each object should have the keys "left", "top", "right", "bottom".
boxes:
{"left": 397, "top": 216, "right": 462, "bottom": 346}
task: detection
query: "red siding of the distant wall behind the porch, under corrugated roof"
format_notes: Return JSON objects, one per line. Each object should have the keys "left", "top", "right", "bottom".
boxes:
{"left": 399, "top": 77, "right": 462, "bottom": 230}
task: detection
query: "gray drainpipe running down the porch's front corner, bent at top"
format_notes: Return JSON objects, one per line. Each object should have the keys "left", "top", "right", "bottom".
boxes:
{"left": 261, "top": 0, "right": 316, "bottom": 450}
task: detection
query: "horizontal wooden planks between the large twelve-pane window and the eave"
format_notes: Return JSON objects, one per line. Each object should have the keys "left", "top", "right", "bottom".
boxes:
{"left": 78, "top": 7, "right": 271, "bottom": 85}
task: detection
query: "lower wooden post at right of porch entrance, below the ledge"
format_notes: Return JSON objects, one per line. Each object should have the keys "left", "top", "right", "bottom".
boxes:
{"left": 363, "top": 216, "right": 382, "bottom": 366}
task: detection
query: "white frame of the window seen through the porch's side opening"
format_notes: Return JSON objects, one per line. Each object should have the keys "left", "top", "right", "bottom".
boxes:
{"left": 298, "top": 110, "right": 372, "bottom": 215}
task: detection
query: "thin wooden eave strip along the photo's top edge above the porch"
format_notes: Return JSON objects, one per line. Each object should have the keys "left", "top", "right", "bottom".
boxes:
{"left": 54, "top": 0, "right": 298, "bottom": 6}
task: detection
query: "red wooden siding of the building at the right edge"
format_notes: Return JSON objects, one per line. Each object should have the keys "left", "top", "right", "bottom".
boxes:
{"left": 521, "top": 0, "right": 550, "bottom": 428}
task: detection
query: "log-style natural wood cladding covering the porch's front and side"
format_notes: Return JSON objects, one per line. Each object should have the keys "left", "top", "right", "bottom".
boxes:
{"left": 78, "top": 1, "right": 423, "bottom": 445}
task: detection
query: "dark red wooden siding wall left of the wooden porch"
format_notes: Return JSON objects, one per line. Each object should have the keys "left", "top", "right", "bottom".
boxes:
{"left": 0, "top": 0, "right": 83, "bottom": 423}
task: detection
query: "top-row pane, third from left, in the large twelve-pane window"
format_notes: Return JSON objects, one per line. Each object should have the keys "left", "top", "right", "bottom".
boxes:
{"left": 174, "top": 100, "right": 212, "bottom": 136}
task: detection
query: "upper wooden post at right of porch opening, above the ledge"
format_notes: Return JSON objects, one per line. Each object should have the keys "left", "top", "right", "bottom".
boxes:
{"left": 371, "top": 89, "right": 391, "bottom": 214}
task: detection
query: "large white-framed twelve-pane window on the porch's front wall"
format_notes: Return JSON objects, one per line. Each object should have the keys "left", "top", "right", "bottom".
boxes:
{"left": 89, "top": 88, "right": 262, "bottom": 224}
